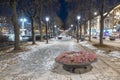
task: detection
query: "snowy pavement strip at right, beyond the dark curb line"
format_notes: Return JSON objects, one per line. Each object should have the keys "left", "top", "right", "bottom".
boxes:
{"left": 80, "top": 41, "right": 120, "bottom": 73}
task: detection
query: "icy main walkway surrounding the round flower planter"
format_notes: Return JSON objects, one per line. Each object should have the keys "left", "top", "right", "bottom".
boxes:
{"left": 0, "top": 40, "right": 120, "bottom": 80}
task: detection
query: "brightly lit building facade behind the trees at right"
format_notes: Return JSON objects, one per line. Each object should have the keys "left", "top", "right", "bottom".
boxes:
{"left": 87, "top": 4, "right": 120, "bottom": 36}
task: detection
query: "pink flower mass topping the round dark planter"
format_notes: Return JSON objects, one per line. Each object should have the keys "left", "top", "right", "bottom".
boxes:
{"left": 55, "top": 51, "right": 96, "bottom": 65}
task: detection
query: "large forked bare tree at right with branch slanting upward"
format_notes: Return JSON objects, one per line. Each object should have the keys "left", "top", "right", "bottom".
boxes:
{"left": 98, "top": 0, "right": 120, "bottom": 45}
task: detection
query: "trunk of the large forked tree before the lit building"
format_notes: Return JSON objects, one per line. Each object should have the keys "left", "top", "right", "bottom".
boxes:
{"left": 99, "top": 0, "right": 104, "bottom": 45}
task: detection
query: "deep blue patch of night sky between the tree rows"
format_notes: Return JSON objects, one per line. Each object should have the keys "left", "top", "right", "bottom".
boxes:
{"left": 58, "top": 0, "right": 68, "bottom": 23}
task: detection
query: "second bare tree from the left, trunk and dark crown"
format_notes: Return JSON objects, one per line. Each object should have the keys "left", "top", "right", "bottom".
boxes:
{"left": 21, "top": 0, "right": 38, "bottom": 44}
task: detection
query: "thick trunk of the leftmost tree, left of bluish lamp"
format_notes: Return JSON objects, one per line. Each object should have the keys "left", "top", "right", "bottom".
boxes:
{"left": 10, "top": 0, "right": 20, "bottom": 50}
